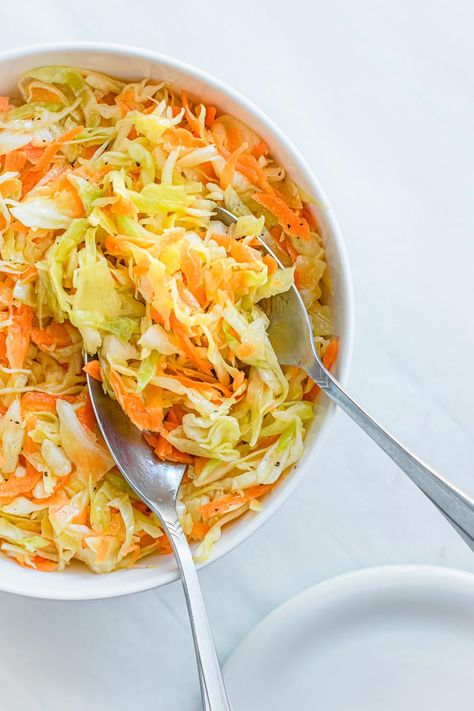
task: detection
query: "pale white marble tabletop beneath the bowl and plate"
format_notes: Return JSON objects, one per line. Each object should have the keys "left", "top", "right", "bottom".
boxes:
{"left": 0, "top": 0, "right": 474, "bottom": 711}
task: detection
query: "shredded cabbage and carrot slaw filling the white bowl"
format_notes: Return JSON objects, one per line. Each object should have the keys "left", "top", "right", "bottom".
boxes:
{"left": 0, "top": 66, "right": 337, "bottom": 573}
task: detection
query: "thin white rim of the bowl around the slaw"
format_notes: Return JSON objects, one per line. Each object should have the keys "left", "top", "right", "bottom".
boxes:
{"left": 0, "top": 41, "right": 355, "bottom": 600}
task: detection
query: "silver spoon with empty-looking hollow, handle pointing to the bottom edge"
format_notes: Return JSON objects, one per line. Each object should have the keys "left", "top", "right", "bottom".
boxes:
{"left": 86, "top": 356, "right": 231, "bottom": 711}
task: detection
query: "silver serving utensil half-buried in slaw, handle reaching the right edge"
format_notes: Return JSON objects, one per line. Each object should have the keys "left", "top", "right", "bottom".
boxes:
{"left": 214, "top": 208, "right": 474, "bottom": 550}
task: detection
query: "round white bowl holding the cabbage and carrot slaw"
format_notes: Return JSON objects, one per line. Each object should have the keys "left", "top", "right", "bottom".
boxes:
{"left": 0, "top": 42, "right": 354, "bottom": 600}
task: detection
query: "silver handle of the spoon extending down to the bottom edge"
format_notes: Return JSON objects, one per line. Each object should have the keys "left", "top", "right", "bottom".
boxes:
{"left": 154, "top": 509, "right": 231, "bottom": 711}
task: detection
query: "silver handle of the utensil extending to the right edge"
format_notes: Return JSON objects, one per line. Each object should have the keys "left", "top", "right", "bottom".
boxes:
{"left": 306, "top": 360, "right": 474, "bottom": 550}
